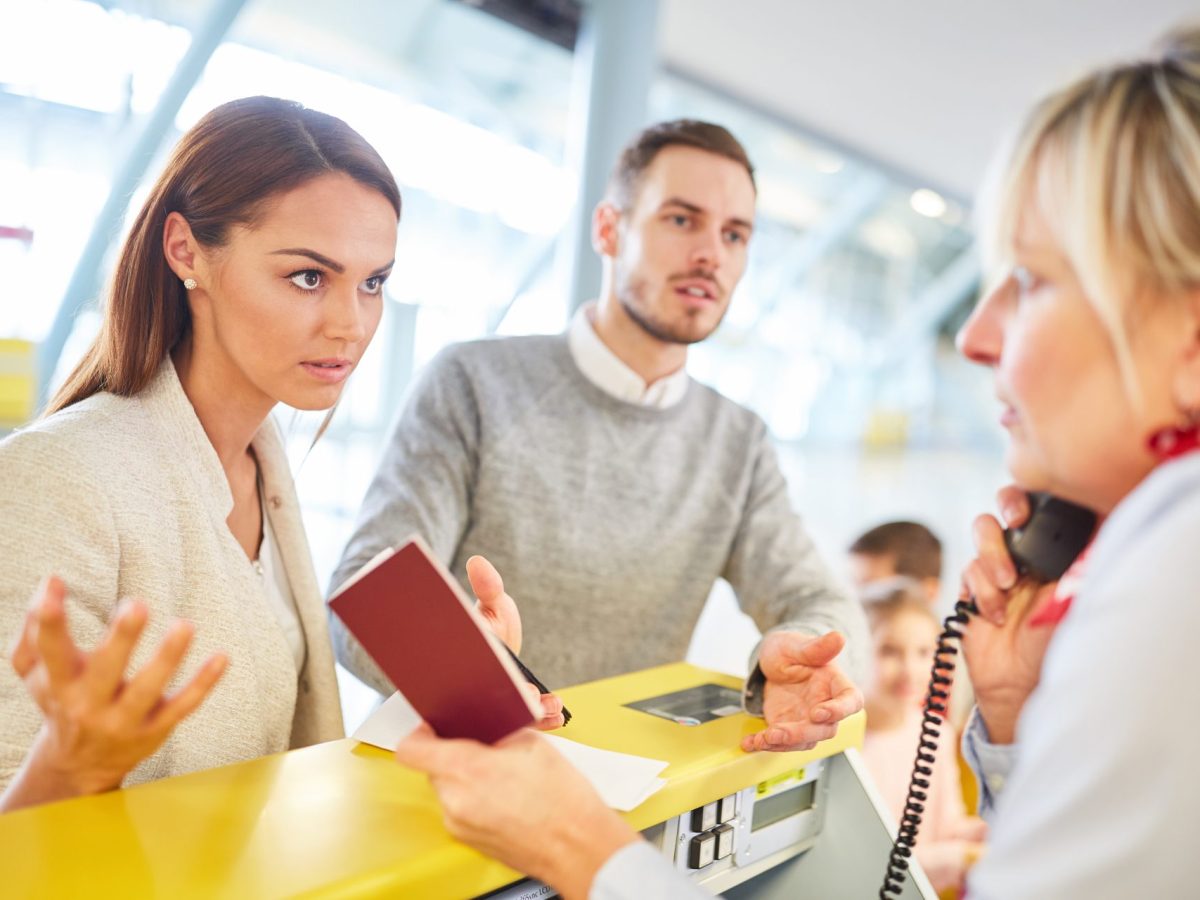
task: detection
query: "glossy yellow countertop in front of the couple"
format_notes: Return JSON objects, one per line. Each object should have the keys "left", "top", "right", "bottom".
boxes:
{"left": 0, "top": 664, "right": 864, "bottom": 900}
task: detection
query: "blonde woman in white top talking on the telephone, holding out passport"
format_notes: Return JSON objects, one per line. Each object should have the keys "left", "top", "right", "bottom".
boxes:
{"left": 398, "top": 24, "right": 1200, "bottom": 900}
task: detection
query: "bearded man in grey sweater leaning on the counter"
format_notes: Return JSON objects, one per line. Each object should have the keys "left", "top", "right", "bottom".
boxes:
{"left": 332, "top": 120, "right": 866, "bottom": 749}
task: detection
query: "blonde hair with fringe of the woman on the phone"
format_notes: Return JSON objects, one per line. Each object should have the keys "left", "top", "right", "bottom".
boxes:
{"left": 983, "top": 24, "right": 1200, "bottom": 397}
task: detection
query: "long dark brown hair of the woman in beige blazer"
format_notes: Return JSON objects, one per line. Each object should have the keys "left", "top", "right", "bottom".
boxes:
{"left": 46, "top": 97, "right": 401, "bottom": 415}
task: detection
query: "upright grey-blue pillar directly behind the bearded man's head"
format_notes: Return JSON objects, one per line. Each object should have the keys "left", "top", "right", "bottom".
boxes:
{"left": 558, "top": 0, "right": 659, "bottom": 311}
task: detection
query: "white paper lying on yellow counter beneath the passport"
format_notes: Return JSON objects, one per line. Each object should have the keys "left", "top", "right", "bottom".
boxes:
{"left": 352, "top": 691, "right": 667, "bottom": 812}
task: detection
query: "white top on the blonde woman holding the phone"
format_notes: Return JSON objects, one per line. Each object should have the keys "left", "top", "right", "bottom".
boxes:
{"left": 968, "top": 454, "right": 1200, "bottom": 900}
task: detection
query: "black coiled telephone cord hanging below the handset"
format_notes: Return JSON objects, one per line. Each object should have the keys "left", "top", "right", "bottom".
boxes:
{"left": 880, "top": 599, "right": 978, "bottom": 900}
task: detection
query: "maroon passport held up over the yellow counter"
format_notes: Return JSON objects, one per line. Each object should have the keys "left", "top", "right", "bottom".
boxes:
{"left": 329, "top": 538, "right": 541, "bottom": 744}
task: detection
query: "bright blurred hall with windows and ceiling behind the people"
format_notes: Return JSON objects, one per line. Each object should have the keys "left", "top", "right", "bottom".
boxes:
{"left": 0, "top": 0, "right": 1196, "bottom": 726}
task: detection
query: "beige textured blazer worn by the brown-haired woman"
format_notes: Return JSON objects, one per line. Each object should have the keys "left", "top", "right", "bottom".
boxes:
{"left": 0, "top": 360, "right": 342, "bottom": 788}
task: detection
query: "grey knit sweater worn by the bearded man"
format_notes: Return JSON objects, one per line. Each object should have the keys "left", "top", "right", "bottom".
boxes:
{"left": 331, "top": 335, "right": 865, "bottom": 692}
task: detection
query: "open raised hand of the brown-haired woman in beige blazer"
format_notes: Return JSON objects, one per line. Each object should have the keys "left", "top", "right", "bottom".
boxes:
{"left": 0, "top": 577, "right": 227, "bottom": 811}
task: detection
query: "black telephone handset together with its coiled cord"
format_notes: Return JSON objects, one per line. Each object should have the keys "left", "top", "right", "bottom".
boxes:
{"left": 880, "top": 493, "right": 1097, "bottom": 900}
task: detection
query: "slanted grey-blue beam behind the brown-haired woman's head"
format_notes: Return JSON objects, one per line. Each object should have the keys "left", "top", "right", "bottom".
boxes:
{"left": 37, "top": 0, "right": 246, "bottom": 407}
